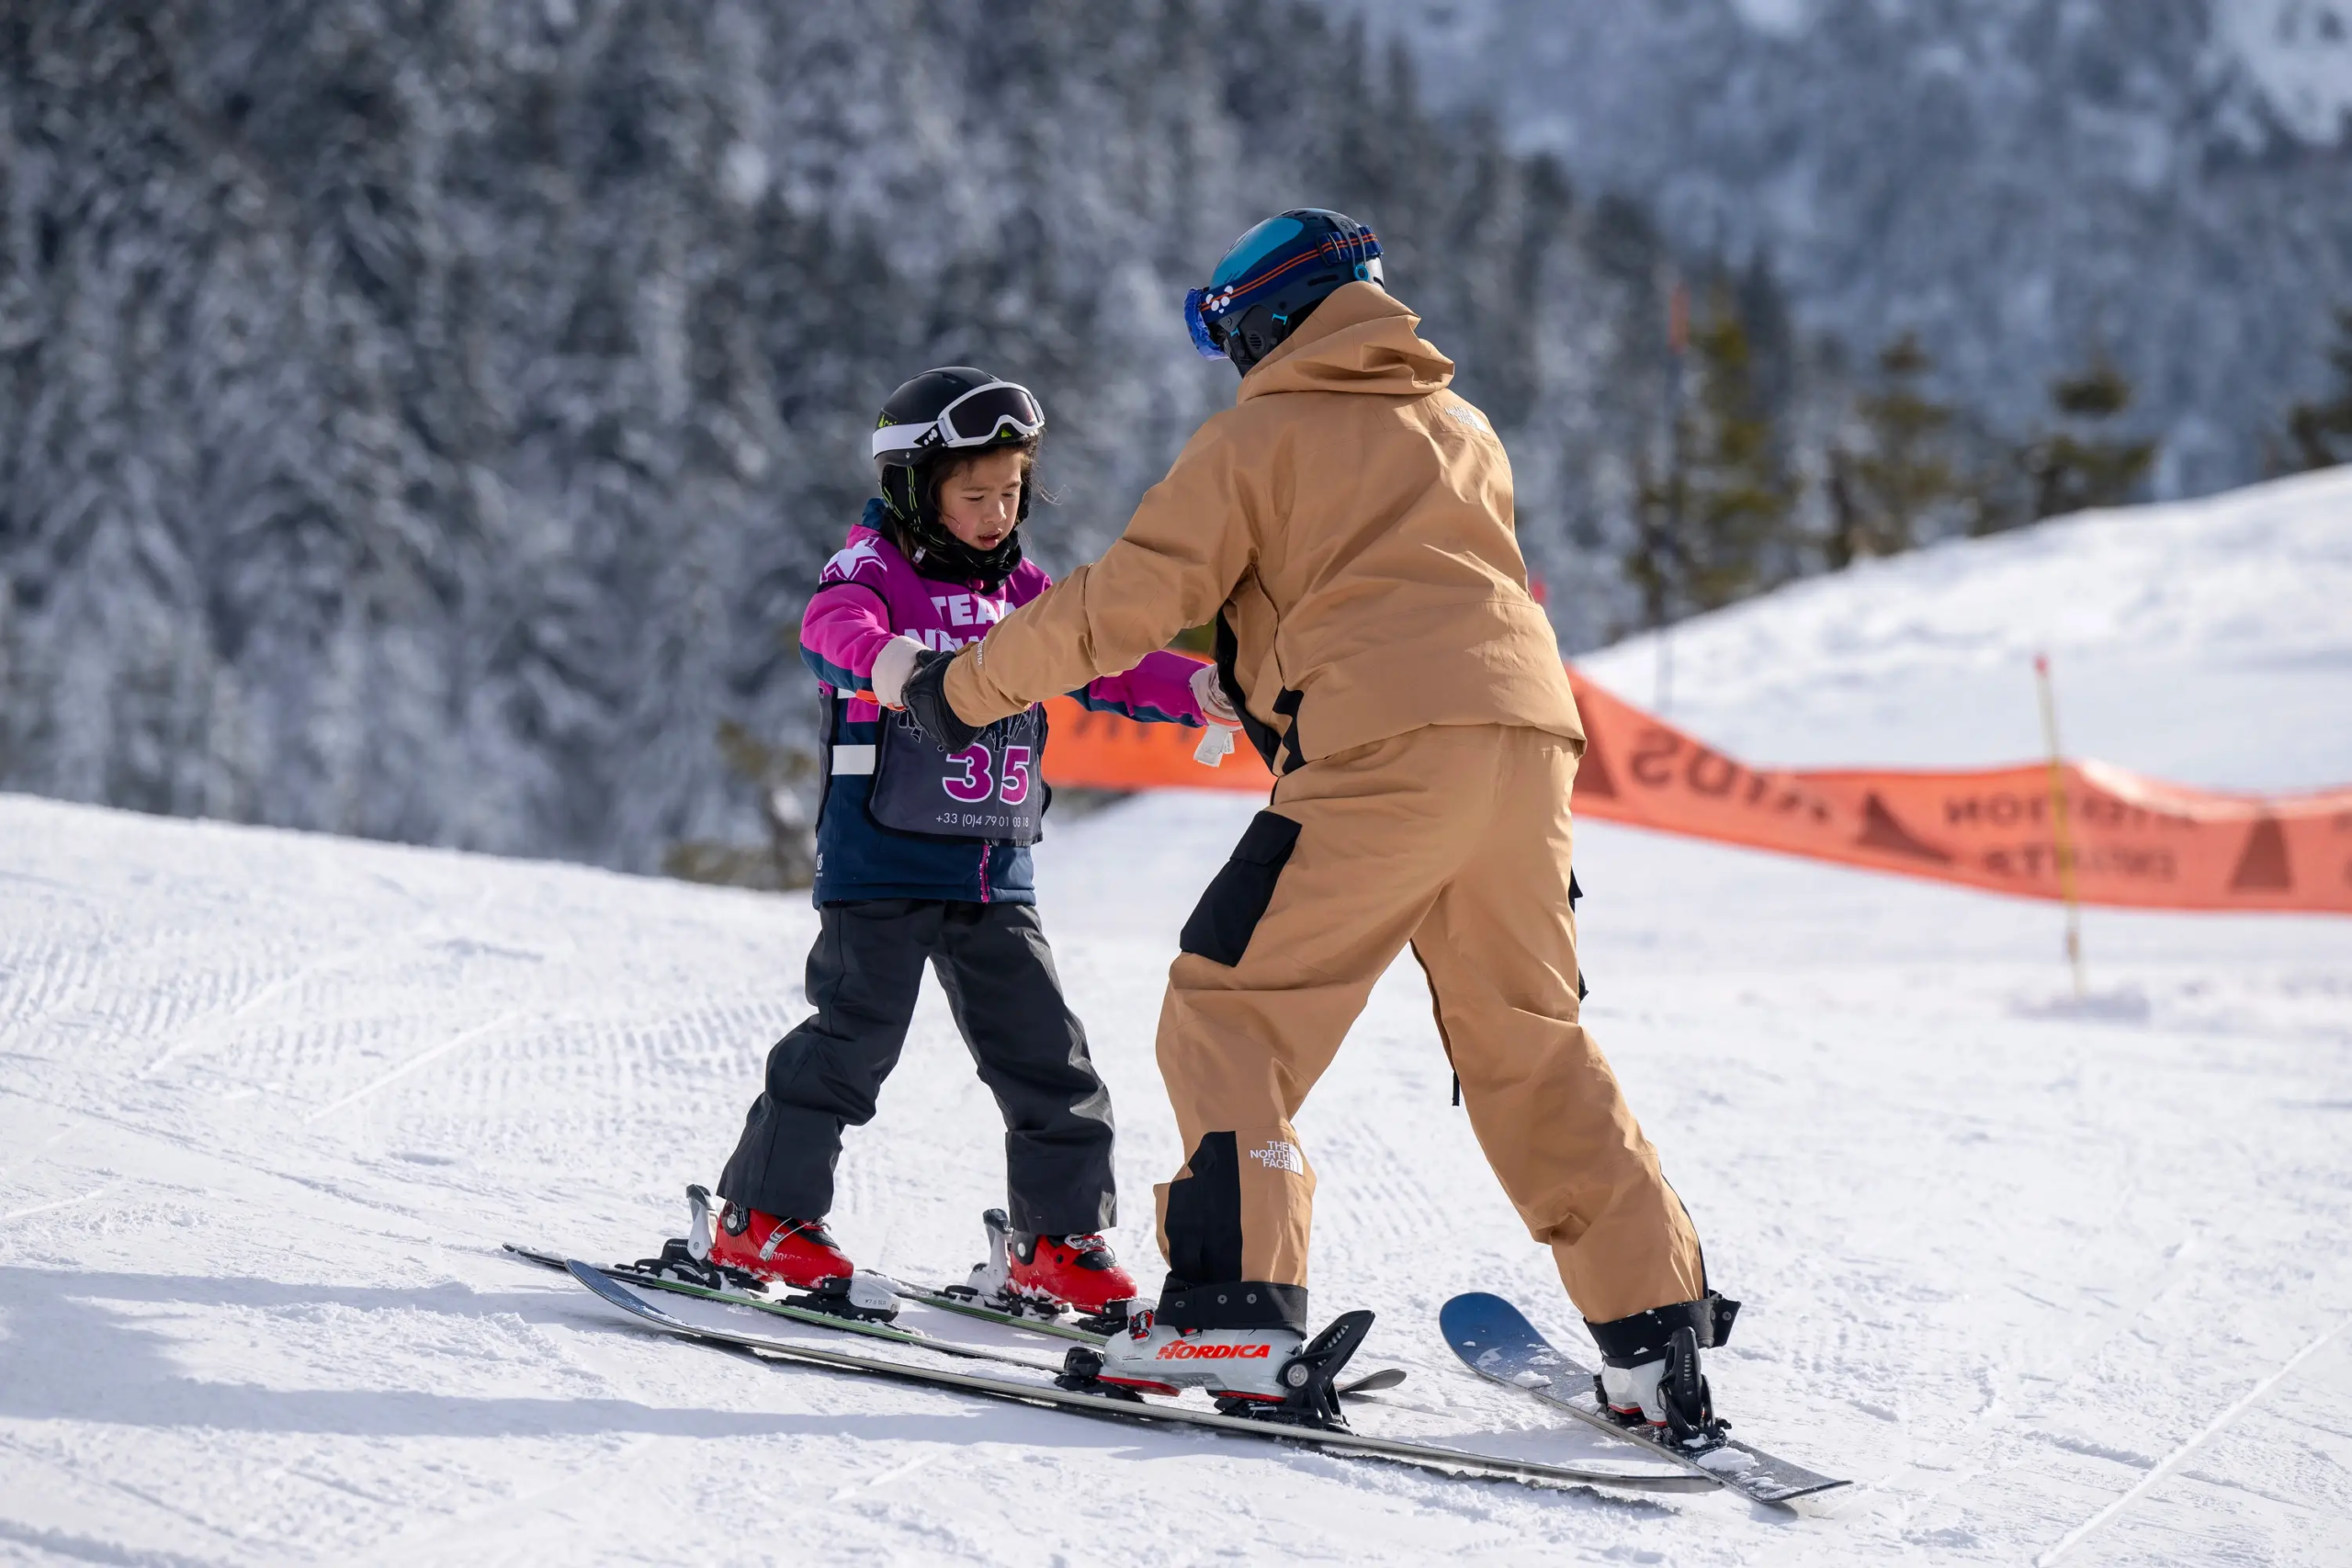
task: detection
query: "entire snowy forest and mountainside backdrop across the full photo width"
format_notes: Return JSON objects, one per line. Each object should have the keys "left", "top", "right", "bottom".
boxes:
{"left": 0, "top": 0, "right": 2352, "bottom": 870}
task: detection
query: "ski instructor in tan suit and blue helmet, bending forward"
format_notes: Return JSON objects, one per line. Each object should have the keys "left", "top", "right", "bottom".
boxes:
{"left": 906, "top": 209, "right": 1736, "bottom": 1441}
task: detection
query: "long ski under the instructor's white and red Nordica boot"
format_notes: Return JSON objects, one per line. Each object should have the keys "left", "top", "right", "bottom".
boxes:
{"left": 564, "top": 1260, "right": 1713, "bottom": 1493}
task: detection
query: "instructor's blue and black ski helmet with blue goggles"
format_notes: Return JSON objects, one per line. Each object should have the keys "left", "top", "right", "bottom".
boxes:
{"left": 1183, "top": 207, "right": 1381, "bottom": 376}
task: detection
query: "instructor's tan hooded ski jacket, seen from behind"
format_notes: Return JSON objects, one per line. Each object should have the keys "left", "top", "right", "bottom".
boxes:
{"left": 945, "top": 282, "right": 1583, "bottom": 773}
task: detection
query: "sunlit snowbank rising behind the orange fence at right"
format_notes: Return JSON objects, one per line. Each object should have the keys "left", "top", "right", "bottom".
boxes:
{"left": 1578, "top": 468, "right": 2352, "bottom": 790}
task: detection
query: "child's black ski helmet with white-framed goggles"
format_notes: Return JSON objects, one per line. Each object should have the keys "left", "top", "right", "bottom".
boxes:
{"left": 873, "top": 365, "right": 1045, "bottom": 585}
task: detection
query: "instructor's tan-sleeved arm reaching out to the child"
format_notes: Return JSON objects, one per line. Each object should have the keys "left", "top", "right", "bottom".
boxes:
{"left": 944, "top": 425, "right": 1256, "bottom": 724}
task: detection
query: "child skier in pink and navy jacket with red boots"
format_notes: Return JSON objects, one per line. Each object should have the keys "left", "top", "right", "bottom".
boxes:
{"left": 696, "top": 367, "right": 1238, "bottom": 1319}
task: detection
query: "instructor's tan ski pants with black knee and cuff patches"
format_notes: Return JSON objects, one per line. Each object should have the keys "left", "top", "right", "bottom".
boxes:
{"left": 1155, "top": 724, "right": 1702, "bottom": 1321}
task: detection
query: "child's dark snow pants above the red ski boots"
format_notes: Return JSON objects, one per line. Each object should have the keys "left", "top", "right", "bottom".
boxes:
{"left": 719, "top": 898, "right": 1117, "bottom": 1236}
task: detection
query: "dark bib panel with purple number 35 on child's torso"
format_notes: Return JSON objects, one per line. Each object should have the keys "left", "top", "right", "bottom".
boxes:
{"left": 865, "top": 705, "right": 1046, "bottom": 846}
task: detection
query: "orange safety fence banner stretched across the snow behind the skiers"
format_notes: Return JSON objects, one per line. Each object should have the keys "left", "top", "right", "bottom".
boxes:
{"left": 1045, "top": 670, "right": 2352, "bottom": 915}
